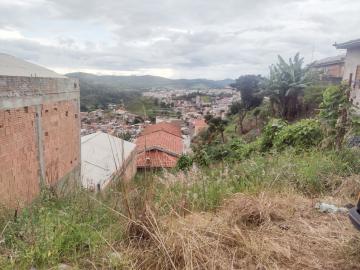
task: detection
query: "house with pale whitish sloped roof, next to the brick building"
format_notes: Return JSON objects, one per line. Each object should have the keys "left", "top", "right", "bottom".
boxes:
{"left": 81, "top": 132, "right": 136, "bottom": 191}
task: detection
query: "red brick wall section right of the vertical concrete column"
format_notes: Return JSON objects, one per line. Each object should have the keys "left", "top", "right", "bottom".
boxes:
{"left": 41, "top": 100, "right": 80, "bottom": 186}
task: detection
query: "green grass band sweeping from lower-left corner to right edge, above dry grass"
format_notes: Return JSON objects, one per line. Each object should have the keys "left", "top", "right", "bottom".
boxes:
{"left": 0, "top": 149, "right": 360, "bottom": 269}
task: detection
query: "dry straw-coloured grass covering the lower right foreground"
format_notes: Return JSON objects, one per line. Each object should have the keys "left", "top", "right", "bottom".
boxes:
{"left": 123, "top": 192, "right": 360, "bottom": 270}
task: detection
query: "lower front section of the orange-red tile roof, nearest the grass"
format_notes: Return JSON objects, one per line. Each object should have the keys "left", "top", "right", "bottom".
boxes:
{"left": 136, "top": 150, "right": 178, "bottom": 168}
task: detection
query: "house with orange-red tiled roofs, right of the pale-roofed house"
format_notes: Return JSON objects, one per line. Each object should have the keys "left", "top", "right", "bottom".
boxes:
{"left": 136, "top": 122, "right": 184, "bottom": 170}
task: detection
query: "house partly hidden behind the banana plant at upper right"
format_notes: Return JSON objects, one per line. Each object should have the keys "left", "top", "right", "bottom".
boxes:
{"left": 311, "top": 54, "right": 345, "bottom": 83}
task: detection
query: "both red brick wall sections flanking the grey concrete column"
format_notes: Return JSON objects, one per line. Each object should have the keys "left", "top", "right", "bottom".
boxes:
{"left": 0, "top": 100, "right": 80, "bottom": 207}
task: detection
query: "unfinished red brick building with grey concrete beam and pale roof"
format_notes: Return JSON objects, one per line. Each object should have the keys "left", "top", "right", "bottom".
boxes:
{"left": 0, "top": 54, "right": 80, "bottom": 207}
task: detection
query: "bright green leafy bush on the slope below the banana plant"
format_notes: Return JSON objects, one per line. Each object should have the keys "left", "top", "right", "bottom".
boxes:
{"left": 273, "top": 119, "right": 322, "bottom": 149}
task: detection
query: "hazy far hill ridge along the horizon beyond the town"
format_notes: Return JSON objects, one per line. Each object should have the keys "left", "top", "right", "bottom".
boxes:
{"left": 66, "top": 72, "right": 234, "bottom": 90}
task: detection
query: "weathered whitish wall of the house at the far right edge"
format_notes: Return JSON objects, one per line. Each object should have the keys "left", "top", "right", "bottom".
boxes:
{"left": 343, "top": 47, "right": 360, "bottom": 105}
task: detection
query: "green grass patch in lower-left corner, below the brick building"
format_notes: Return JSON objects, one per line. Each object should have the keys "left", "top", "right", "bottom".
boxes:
{"left": 0, "top": 191, "right": 124, "bottom": 269}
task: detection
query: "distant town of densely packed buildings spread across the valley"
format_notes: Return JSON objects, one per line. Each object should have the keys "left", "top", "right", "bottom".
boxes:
{"left": 80, "top": 87, "right": 240, "bottom": 141}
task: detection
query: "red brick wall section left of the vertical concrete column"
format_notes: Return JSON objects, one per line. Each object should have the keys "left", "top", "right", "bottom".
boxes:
{"left": 0, "top": 107, "right": 40, "bottom": 207}
